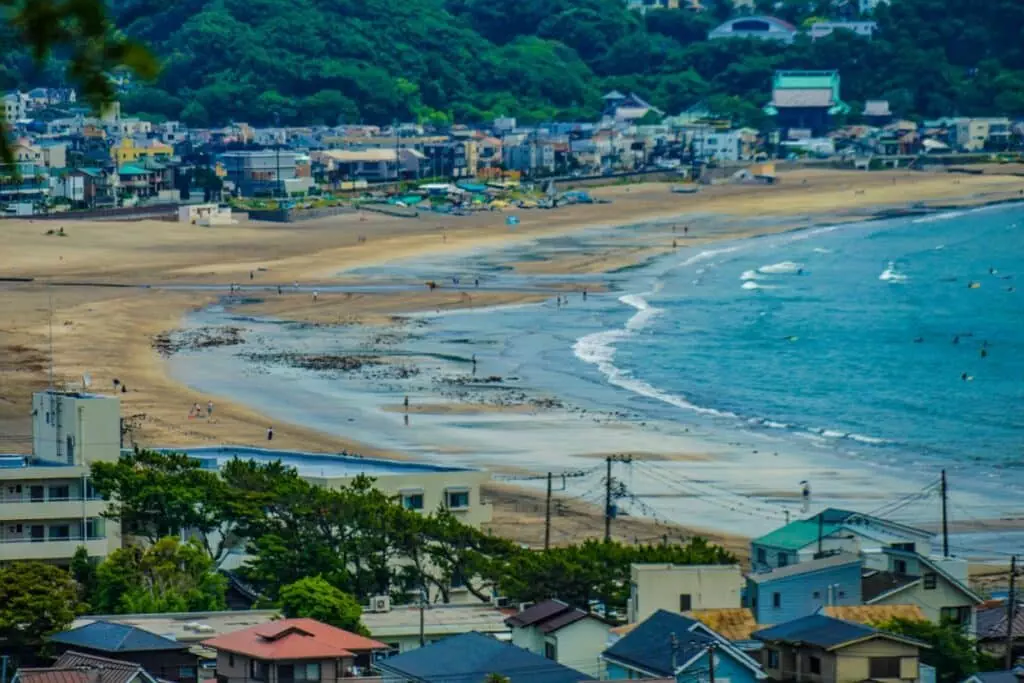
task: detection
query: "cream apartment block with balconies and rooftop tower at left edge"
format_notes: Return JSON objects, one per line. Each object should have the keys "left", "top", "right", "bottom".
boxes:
{"left": 0, "top": 390, "right": 121, "bottom": 564}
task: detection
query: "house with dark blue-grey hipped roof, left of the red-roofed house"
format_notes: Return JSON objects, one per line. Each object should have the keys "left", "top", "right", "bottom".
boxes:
{"left": 48, "top": 620, "right": 199, "bottom": 683}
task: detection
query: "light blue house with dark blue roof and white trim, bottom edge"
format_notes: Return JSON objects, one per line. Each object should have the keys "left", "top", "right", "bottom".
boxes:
{"left": 601, "top": 609, "right": 766, "bottom": 683}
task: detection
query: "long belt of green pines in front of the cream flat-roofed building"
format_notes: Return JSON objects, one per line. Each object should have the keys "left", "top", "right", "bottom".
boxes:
{"left": 94, "top": 452, "right": 735, "bottom": 623}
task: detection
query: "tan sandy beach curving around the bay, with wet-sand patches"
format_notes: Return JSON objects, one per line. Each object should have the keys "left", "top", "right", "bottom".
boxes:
{"left": 6, "top": 171, "right": 1024, "bottom": 552}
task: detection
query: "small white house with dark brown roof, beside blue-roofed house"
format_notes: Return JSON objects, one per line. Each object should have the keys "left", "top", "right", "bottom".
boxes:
{"left": 505, "top": 600, "right": 610, "bottom": 671}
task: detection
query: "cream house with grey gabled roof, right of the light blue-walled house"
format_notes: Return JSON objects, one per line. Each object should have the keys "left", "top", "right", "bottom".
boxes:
{"left": 862, "top": 548, "right": 982, "bottom": 634}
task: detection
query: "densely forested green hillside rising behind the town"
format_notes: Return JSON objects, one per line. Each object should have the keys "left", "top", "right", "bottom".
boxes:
{"left": 0, "top": 0, "right": 1024, "bottom": 125}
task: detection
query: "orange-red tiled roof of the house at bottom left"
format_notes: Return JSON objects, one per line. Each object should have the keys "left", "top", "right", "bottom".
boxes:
{"left": 203, "top": 618, "right": 387, "bottom": 659}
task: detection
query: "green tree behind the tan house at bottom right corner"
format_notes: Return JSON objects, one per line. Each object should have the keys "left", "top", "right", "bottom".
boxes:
{"left": 877, "top": 618, "right": 998, "bottom": 683}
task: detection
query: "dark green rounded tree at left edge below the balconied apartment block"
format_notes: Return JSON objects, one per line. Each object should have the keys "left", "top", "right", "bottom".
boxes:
{"left": 0, "top": 562, "right": 79, "bottom": 660}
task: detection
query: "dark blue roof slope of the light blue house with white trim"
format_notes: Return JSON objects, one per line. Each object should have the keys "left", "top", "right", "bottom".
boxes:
{"left": 604, "top": 609, "right": 715, "bottom": 677}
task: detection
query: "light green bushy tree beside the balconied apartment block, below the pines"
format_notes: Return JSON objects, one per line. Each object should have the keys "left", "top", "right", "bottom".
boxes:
{"left": 92, "top": 537, "right": 227, "bottom": 614}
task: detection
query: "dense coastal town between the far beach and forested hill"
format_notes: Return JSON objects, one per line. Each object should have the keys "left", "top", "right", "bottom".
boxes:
{"left": 0, "top": 73, "right": 1024, "bottom": 216}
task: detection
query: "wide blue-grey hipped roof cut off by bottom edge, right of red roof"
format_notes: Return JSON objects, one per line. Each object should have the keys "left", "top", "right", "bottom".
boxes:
{"left": 374, "top": 631, "right": 594, "bottom": 683}
